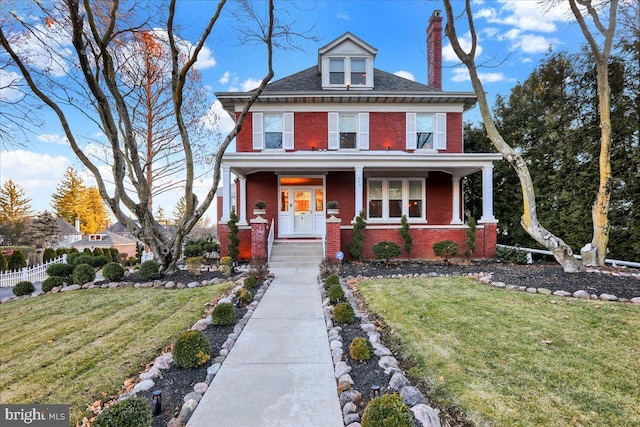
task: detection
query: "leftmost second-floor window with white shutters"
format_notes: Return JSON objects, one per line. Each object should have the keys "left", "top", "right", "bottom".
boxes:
{"left": 251, "top": 112, "right": 294, "bottom": 150}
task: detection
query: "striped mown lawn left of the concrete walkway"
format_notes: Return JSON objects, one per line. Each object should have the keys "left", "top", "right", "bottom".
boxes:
{"left": 0, "top": 285, "right": 229, "bottom": 425}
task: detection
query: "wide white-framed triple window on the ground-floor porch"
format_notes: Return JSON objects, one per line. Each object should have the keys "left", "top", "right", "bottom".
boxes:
{"left": 367, "top": 178, "right": 425, "bottom": 220}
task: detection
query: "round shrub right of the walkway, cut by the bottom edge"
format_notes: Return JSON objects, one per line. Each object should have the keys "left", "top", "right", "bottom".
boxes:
{"left": 362, "top": 393, "right": 414, "bottom": 427}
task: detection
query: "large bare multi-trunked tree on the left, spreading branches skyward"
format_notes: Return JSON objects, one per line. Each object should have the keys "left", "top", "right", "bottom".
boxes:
{"left": 0, "top": 0, "right": 280, "bottom": 272}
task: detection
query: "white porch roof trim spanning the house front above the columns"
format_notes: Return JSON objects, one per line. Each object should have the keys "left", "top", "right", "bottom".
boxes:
{"left": 223, "top": 151, "right": 502, "bottom": 177}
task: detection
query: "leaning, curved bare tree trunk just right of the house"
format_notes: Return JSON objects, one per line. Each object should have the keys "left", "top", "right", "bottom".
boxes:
{"left": 444, "top": 0, "right": 584, "bottom": 272}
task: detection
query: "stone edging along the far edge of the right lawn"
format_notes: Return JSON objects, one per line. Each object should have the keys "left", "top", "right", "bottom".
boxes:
{"left": 347, "top": 269, "right": 640, "bottom": 304}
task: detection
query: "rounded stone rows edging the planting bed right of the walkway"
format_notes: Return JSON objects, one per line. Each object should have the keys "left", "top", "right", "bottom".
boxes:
{"left": 318, "top": 278, "right": 441, "bottom": 427}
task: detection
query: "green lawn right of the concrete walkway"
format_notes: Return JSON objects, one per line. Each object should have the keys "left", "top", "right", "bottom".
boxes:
{"left": 358, "top": 278, "right": 640, "bottom": 427}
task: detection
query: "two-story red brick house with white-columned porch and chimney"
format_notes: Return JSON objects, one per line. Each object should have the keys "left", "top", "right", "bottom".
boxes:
{"left": 216, "top": 12, "right": 501, "bottom": 258}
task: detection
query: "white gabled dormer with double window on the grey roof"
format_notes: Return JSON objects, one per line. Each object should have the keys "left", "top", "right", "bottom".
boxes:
{"left": 318, "top": 32, "right": 378, "bottom": 90}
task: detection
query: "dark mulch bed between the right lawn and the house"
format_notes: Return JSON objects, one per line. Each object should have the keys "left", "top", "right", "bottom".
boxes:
{"left": 342, "top": 261, "right": 640, "bottom": 299}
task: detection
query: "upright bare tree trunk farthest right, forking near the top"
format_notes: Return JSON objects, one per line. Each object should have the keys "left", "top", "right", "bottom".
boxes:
{"left": 569, "top": 0, "right": 618, "bottom": 265}
